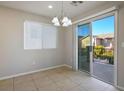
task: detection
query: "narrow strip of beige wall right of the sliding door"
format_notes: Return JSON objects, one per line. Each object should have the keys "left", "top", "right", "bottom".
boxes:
{"left": 118, "top": 5, "right": 124, "bottom": 88}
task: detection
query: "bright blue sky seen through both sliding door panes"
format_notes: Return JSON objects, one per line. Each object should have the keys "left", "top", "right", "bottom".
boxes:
{"left": 78, "top": 16, "right": 114, "bottom": 36}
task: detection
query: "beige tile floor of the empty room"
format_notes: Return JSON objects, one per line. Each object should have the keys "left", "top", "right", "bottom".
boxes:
{"left": 0, "top": 67, "right": 117, "bottom": 91}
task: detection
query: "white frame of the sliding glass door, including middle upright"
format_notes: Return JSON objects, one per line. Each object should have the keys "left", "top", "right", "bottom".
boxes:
{"left": 73, "top": 10, "right": 118, "bottom": 87}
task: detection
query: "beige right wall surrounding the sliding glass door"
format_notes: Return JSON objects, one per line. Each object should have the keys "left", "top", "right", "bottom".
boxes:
{"left": 64, "top": 2, "right": 124, "bottom": 88}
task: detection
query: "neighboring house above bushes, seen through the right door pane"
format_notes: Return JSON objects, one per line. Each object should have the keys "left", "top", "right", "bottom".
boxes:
{"left": 93, "top": 33, "right": 114, "bottom": 50}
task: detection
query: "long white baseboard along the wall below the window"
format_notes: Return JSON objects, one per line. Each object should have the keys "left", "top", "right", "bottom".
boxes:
{"left": 0, "top": 64, "right": 67, "bottom": 80}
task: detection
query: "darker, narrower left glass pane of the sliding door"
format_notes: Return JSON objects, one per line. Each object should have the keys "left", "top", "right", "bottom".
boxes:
{"left": 78, "top": 24, "right": 90, "bottom": 72}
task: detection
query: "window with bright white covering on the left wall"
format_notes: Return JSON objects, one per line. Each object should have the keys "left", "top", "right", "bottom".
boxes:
{"left": 24, "top": 21, "right": 57, "bottom": 49}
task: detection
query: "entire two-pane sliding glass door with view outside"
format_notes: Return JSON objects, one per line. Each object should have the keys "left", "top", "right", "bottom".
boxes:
{"left": 78, "top": 15, "right": 115, "bottom": 84}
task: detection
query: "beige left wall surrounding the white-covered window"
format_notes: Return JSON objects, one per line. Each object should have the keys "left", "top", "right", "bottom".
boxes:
{"left": 0, "top": 7, "right": 64, "bottom": 78}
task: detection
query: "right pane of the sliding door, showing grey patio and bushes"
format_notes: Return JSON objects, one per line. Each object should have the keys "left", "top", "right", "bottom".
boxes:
{"left": 92, "top": 16, "right": 115, "bottom": 84}
